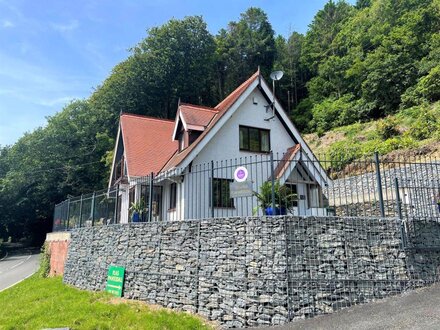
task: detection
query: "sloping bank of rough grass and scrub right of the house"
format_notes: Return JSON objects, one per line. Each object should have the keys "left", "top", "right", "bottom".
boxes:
{"left": 305, "top": 102, "right": 440, "bottom": 165}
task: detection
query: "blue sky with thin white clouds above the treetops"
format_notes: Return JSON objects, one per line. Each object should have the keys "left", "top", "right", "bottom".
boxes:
{"left": 0, "top": 0, "right": 354, "bottom": 146}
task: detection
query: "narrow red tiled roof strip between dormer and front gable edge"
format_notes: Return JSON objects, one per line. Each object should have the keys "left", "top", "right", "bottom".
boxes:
{"left": 162, "top": 70, "right": 260, "bottom": 171}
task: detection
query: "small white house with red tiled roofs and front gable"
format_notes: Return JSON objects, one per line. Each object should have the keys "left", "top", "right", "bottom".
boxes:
{"left": 109, "top": 71, "right": 329, "bottom": 223}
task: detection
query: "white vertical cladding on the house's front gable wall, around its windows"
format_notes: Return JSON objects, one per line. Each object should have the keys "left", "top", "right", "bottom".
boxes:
{"left": 180, "top": 88, "right": 295, "bottom": 219}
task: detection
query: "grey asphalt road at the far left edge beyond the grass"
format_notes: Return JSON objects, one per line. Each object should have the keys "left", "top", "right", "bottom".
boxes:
{"left": 0, "top": 250, "right": 39, "bottom": 291}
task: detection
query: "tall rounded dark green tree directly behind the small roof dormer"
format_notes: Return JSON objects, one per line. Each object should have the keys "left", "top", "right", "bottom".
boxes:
{"left": 133, "top": 16, "right": 217, "bottom": 118}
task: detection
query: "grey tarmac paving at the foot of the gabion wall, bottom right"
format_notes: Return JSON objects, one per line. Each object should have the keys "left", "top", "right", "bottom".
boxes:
{"left": 251, "top": 284, "right": 440, "bottom": 330}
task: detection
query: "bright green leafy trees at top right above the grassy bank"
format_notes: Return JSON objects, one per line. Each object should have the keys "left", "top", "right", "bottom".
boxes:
{"left": 299, "top": 0, "right": 440, "bottom": 131}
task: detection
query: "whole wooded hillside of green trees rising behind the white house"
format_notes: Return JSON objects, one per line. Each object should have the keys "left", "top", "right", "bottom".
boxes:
{"left": 0, "top": 0, "right": 440, "bottom": 243}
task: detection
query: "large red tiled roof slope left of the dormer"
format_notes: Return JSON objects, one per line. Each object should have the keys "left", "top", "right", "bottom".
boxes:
{"left": 120, "top": 114, "right": 178, "bottom": 177}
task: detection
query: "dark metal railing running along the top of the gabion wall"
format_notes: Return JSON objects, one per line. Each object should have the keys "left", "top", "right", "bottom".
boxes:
{"left": 53, "top": 153, "right": 440, "bottom": 231}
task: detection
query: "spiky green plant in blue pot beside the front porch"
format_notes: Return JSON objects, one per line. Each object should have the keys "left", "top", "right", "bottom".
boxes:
{"left": 254, "top": 180, "right": 297, "bottom": 215}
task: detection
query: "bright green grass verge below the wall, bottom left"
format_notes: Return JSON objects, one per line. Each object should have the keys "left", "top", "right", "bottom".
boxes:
{"left": 0, "top": 276, "right": 211, "bottom": 330}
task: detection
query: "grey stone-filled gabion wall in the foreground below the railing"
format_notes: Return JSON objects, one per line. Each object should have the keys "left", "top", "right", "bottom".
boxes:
{"left": 64, "top": 217, "right": 440, "bottom": 327}
